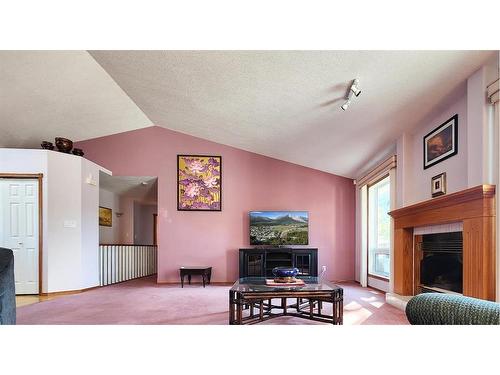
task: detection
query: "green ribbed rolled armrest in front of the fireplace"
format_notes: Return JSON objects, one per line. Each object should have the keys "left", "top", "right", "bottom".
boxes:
{"left": 406, "top": 293, "right": 500, "bottom": 325}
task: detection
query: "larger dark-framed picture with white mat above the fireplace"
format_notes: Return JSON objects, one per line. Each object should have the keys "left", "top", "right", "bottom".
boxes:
{"left": 424, "top": 114, "right": 458, "bottom": 169}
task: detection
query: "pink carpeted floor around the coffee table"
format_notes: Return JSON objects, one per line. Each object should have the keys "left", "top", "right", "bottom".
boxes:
{"left": 17, "top": 278, "right": 408, "bottom": 325}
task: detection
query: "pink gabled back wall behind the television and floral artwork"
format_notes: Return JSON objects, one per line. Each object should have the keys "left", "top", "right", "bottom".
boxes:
{"left": 76, "top": 126, "right": 355, "bottom": 282}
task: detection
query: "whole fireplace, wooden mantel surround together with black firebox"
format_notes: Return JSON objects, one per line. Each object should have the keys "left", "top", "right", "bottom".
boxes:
{"left": 389, "top": 185, "right": 495, "bottom": 301}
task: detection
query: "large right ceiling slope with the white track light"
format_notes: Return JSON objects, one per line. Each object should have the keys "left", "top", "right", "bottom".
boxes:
{"left": 90, "top": 51, "right": 493, "bottom": 177}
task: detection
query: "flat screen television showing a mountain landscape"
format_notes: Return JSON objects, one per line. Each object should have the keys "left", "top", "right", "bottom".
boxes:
{"left": 250, "top": 211, "right": 309, "bottom": 245}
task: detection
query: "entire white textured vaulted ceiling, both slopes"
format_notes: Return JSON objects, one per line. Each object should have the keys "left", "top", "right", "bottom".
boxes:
{"left": 0, "top": 51, "right": 494, "bottom": 177}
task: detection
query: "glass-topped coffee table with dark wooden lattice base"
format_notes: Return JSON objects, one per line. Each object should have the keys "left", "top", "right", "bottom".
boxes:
{"left": 229, "top": 276, "right": 344, "bottom": 324}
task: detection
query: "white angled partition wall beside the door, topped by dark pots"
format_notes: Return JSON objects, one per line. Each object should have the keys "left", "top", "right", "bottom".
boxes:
{"left": 0, "top": 149, "right": 111, "bottom": 293}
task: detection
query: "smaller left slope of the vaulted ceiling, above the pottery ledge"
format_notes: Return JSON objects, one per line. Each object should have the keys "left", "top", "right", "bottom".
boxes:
{"left": 0, "top": 51, "right": 152, "bottom": 148}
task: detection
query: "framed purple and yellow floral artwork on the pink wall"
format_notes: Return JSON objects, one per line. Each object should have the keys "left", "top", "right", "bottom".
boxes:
{"left": 177, "top": 155, "right": 222, "bottom": 211}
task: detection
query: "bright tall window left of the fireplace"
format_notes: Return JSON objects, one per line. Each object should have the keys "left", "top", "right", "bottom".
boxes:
{"left": 368, "top": 176, "right": 391, "bottom": 278}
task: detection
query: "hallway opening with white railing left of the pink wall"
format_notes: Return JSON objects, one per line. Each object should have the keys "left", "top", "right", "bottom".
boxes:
{"left": 99, "top": 173, "right": 159, "bottom": 286}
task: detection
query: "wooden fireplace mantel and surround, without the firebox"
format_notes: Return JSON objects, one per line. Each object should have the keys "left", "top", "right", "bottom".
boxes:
{"left": 389, "top": 185, "right": 495, "bottom": 301}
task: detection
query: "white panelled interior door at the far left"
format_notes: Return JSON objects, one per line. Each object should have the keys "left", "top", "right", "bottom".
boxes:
{"left": 0, "top": 178, "right": 39, "bottom": 294}
